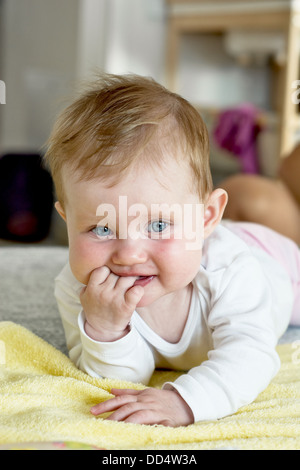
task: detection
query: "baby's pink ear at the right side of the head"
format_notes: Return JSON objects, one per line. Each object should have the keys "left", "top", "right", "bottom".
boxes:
{"left": 204, "top": 188, "right": 228, "bottom": 238}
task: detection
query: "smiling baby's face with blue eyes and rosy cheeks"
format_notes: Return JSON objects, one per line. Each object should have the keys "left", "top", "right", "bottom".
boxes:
{"left": 58, "top": 159, "right": 216, "bottom": 307}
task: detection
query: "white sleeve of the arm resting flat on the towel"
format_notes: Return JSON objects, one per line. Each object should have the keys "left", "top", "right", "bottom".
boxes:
{"left": 164, "top": 257, "right": 280, "bottom": 421}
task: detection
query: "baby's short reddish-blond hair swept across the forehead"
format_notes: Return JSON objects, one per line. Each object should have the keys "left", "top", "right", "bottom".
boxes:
{"left": 44, "top": 74, "right": 212, "bottom": 204}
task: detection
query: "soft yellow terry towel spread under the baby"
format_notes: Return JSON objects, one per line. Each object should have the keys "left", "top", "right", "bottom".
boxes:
{"left": 0, "top": 322, "right": 300, "bottom": 450}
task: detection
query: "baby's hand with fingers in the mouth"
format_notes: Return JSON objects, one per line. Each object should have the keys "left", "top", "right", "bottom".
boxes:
{"left": 80, "top": 266, "right": 144, "bottom": 342}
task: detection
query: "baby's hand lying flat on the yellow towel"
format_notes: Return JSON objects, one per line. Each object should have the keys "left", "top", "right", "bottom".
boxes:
{"left": 91, "top": 388, "right": 194, "bottom": 427}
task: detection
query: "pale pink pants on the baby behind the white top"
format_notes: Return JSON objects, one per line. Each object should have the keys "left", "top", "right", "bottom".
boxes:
{"left": 224, "top": 221, "right": 300, "bottom": 326}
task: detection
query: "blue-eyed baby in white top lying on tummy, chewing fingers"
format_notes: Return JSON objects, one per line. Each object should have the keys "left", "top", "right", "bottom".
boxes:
{"left": 45, "top": 75, "right": 300, "bottom": 426}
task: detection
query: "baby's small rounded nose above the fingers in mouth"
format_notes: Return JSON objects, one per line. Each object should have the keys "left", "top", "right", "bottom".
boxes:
{"left": 112, "top": 240, "right": 148, "bottom": 266}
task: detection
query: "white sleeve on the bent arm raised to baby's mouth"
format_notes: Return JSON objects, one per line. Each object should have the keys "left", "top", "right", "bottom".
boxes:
{"left": 55, "top": 272, "right": 155, "bottom": 384}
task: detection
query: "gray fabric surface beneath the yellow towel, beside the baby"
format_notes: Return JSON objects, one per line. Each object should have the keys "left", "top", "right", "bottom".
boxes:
{"left": 0, "top": 246, "right": 300, "bottom": 353}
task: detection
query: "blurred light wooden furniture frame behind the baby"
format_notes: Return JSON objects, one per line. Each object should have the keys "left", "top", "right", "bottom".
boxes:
{"left": 166, "top": 0, "right": 300, "bottom": 160}
